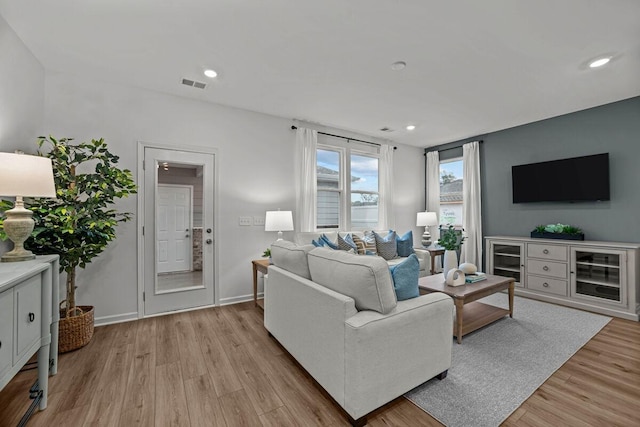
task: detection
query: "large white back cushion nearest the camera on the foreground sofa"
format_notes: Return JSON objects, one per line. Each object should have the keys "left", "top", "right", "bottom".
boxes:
{"left": 308, "top": 248, "right": 397, "bottom": 314}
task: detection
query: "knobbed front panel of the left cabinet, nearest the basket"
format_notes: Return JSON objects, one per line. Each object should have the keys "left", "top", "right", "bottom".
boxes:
{"left": 14, "top": 274, "right": 42, "bottom": 363}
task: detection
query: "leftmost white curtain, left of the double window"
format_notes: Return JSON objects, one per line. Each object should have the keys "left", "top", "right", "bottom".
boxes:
{"left": 295, "top": 127, "right": 318, "bottom": 231}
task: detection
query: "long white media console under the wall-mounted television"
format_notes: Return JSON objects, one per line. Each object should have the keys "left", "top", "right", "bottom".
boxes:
{"left": 486, "top": 236, "right": 640, "bottom": 321}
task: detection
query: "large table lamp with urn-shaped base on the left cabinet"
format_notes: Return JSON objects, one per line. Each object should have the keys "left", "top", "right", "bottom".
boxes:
{"left": 0, "top": 153, "right": 56, "bottom": 262}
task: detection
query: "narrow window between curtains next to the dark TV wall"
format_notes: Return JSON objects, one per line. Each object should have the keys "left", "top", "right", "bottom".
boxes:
{"left": 440, "top": 158, "right": 463, "bottom": 227}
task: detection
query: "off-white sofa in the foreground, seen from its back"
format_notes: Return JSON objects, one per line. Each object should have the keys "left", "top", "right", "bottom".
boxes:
{"left": 264, "top": 241, "right": 453, "bottom": 425}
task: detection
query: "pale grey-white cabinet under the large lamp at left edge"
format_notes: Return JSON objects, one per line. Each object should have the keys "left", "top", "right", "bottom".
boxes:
{"left": 0, "top": 255, "right": 59, "bottom": 412}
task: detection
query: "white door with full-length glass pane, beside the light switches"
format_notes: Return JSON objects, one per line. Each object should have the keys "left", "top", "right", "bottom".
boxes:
{"left": 142, "top": 147, "right": 215, "bottom": 316}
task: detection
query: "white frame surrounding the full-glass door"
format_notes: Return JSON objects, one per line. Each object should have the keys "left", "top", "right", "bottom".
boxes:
{"left": 136, "top": 140, "right": 220, "bottom": 319}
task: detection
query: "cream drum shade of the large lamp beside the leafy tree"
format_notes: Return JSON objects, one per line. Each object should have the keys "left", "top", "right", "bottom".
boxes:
{"left": 0, "top": 153, "right": 56, "bottom": 197}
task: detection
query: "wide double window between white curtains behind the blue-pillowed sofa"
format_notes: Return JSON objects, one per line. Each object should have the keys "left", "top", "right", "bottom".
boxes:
{"left": 316, "top": 146, "right": 379, "bottom": 230}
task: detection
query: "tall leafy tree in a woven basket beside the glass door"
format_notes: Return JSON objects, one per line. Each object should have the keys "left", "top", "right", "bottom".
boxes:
{"left": 0, "top": 136, "right": 136, "bottom": 353}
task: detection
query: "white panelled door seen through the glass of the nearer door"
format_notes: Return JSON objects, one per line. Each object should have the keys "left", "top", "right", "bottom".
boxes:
{"left": 156, "top": 184, "right": 193, "bottom": 273}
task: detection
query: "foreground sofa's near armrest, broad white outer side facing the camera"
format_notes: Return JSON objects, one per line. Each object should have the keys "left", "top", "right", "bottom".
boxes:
{"left": 345, "top": 293, "right": 453, "bottom": 418}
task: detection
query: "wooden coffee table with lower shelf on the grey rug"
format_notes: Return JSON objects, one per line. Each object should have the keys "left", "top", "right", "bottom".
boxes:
{"left": 418, "top": 273, "right": 515, "bottom": 344}
